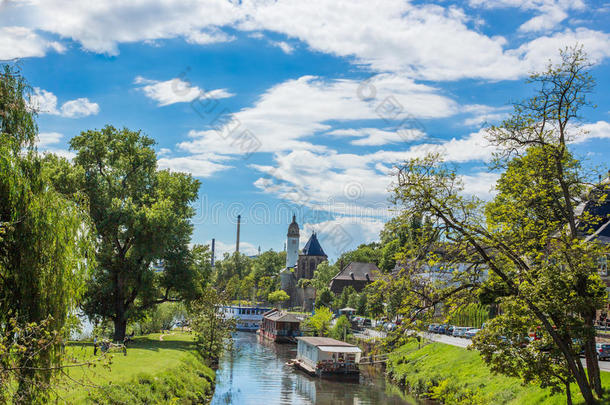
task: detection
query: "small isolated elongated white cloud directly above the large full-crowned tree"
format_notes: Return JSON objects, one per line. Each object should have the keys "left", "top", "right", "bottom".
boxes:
{"left": 134, "top": 76, "right": 234, "bottom": 106}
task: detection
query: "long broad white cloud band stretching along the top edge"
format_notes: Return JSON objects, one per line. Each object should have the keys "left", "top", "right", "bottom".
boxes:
{"left": 8, "top": 0, "right": 610, "bottom": 80}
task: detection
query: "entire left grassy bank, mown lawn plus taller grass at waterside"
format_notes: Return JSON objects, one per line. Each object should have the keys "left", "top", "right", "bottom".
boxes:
{"left": 58, "top": 332, "right": 215, "bottom": 404}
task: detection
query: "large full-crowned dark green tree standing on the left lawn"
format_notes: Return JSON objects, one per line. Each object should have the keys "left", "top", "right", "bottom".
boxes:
{"left": 70, "top": 126, "right": 201, "bottom": 340}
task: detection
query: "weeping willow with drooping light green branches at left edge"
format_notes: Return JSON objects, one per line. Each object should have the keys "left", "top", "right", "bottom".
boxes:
{"left": 0, "top": 67, "right": 93, "bottom": 403}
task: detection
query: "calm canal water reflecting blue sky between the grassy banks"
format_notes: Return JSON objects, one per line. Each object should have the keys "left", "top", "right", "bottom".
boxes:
{"left": 212, "top": 332, "right": 417, "bottom": 405}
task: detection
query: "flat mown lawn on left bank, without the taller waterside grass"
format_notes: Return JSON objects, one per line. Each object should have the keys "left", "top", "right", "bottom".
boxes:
{"left": 59, "top": 332, "right": 208, "bottom": 403}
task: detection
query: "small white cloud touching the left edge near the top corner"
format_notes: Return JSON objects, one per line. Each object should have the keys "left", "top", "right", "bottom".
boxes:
{"left": 0, "top": 27, "right": 65, "bottom": 60}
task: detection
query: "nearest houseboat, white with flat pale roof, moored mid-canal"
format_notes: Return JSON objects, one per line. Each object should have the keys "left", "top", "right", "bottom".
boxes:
{"left": 292, "top": 337, "right": 362, "bottom": 378}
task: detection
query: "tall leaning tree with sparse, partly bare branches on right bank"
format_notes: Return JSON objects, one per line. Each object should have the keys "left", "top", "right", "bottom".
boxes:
{"left": 394, "top": 48, "right": 607, "bottom": 404}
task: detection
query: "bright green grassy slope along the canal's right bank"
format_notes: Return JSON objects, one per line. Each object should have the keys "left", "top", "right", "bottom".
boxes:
{"left": 387, "top": 342, "right": 610, "bottom": 405}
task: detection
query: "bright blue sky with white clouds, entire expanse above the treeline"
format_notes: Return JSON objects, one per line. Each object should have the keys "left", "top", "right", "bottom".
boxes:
{"left": 0, "top": 0, "right": 610, "bottom": 258}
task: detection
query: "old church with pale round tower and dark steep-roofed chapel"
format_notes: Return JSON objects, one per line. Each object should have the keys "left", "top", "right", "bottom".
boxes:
{"left": 280, "top": 215, "right": 328, "bottom": 311}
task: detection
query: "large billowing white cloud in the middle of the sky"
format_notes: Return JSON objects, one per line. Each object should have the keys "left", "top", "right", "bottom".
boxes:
{"left": 178, "top": 74, "right": 458, "bottom": 154}
